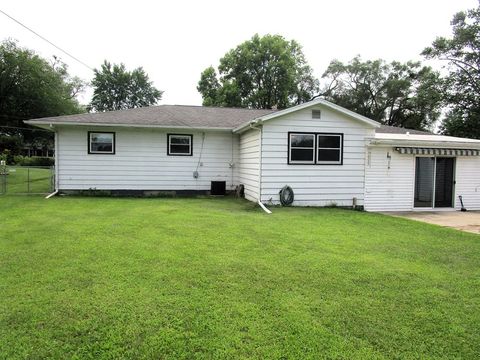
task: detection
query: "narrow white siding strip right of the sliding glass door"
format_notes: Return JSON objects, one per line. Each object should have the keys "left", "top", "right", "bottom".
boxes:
{"left": 455, "top": 156, "right": 480, "bottom": 210}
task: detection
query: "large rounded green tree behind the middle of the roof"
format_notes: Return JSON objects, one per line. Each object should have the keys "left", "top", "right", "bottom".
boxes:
{"left": 197, "top": 34, "right": 318, "bottom": 109}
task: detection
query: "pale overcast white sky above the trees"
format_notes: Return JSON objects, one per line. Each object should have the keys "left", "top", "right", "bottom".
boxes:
{"left": 0, "top": 0, "right": 478, "bottom": 105}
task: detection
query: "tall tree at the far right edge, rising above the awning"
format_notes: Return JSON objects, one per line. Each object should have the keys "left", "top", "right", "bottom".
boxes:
{"left": 422, "top": 7, "right": 480, "bottom": 139}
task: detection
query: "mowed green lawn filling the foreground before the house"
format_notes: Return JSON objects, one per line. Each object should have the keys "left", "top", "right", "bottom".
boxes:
{"left": 0, "top": 196, "right": 480, "bottom": 359}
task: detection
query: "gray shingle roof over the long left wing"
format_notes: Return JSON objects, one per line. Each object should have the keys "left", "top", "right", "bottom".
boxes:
{"left": 28, "top": 105, "right": 275, "bottom": 129}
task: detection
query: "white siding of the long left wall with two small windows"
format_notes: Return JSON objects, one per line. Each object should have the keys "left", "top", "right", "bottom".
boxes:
{"left": 57, "top": 126, "right": 238, "bottom": 190}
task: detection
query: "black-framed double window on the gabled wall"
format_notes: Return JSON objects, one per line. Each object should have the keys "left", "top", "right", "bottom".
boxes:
{"left": 288, "top": 132, "right": 343, "bottom": 165}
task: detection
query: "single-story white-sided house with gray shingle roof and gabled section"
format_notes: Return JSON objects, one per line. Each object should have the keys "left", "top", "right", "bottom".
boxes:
{"left": 26, "top": 99, "right": 480, "bottom": 211}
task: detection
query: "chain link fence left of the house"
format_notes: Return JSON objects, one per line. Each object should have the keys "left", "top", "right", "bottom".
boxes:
{"left": 0, "top": 165, "right": 55, "bottom": 195}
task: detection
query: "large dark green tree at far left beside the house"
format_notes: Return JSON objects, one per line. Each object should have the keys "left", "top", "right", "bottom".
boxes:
{"left": 0, "top": 40, "right": 85, "bottom": 154}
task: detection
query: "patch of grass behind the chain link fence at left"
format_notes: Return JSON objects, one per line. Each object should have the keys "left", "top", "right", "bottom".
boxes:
{"left": 0, "top": 166, "right": 53, "bottom": 194}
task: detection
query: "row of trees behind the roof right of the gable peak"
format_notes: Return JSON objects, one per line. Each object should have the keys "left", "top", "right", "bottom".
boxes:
{"left": 319, "top": 56, "right": 441, "bottom": 129}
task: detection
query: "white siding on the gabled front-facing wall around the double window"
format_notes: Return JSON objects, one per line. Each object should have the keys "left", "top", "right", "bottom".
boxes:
{"left": 261, "top": 107, "right": 374, "bottom": 206}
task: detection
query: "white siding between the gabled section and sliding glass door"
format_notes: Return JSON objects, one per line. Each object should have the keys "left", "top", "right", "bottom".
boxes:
{"left": 365, "top": 147, "right": 415, "bottom": 211}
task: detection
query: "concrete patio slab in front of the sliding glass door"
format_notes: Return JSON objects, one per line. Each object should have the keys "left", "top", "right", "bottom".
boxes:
{"left": 384, "top": 211, "right": 480, "bottom": 234}
